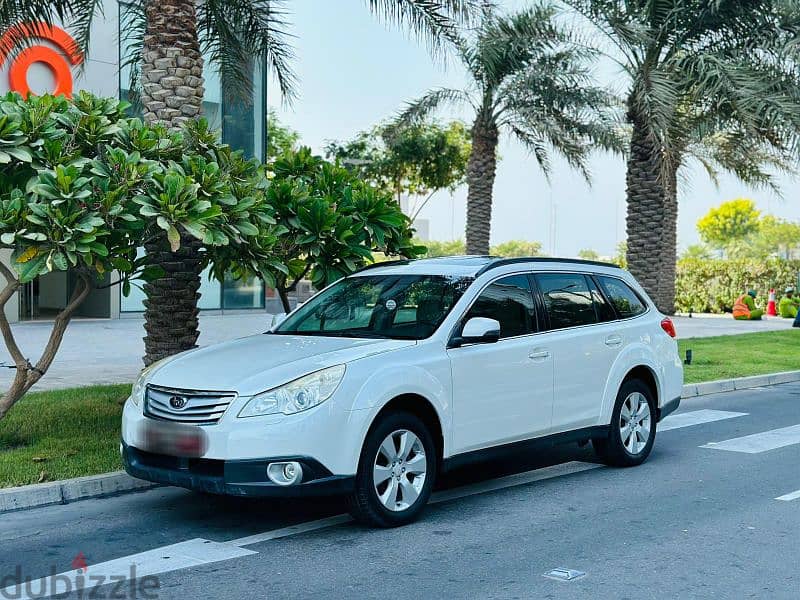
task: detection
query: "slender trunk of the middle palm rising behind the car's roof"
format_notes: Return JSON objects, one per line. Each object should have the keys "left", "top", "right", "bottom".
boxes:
{"left": 466, "top": 118, "right": 498, "bottom": 254}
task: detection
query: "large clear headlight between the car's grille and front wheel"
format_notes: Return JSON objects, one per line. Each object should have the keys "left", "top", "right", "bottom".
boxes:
{"left": 239, "top": 365, "right": 345, "bottom": 417}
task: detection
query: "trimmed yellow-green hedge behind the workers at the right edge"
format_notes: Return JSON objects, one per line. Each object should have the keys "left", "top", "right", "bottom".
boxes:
{"left": 675, "top": 258, "right": 800, "bottom": 313}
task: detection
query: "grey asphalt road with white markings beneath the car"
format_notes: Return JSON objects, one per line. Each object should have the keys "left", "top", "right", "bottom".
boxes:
{"left": 0, "top": 384, "right": 800, "bottom": 600}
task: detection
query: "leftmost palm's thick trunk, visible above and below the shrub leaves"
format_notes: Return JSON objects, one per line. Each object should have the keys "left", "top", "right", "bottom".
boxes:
{"left": 142, "top": 0, "right": 204, "bottom": 365}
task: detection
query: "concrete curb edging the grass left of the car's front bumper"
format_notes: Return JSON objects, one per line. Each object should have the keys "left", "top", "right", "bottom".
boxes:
{"left": 0, "top": 471, "right": 159, "bottom": 514}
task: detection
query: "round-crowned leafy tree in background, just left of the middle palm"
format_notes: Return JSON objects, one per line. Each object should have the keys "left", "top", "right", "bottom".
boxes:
{"left": 326, "top": 121, "right": 470, "bottom": 221}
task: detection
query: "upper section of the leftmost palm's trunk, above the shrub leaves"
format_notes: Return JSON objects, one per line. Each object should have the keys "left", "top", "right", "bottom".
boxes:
{"left": 142, "top": 0, "right": 203, "bottom": 129}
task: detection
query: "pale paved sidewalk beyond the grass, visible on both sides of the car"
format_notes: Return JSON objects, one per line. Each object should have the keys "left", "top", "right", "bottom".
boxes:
{"left": 0, "top": 312, "right": 792, "bottom": 390}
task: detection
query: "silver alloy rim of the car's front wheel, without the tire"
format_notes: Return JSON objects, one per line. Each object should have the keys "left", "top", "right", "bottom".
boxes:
{"left": 372, "top": 429, "right": 428, "bottom": 512}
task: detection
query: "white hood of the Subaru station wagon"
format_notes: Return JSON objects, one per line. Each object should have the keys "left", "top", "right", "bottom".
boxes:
{"left": 147, "top": 334, "right": 416, "bottom": 396}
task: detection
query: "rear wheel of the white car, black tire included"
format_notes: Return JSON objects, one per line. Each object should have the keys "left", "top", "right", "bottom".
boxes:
{"left": 592, "top": 379, "right": 656, "bottom": 467}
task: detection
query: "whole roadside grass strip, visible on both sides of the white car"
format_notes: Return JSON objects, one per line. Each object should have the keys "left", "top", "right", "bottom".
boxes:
{"left": 0, "top": 329, "right": 800, "bottom": 487}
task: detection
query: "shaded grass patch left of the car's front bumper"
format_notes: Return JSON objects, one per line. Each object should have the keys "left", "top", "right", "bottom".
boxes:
{"left": 0, "top": 385, "right": 131, "bottom": 487}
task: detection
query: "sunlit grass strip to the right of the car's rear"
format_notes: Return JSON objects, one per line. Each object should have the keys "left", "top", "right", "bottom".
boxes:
{"left": 678, "top": 329, "right": 800, "bottom": 383}
